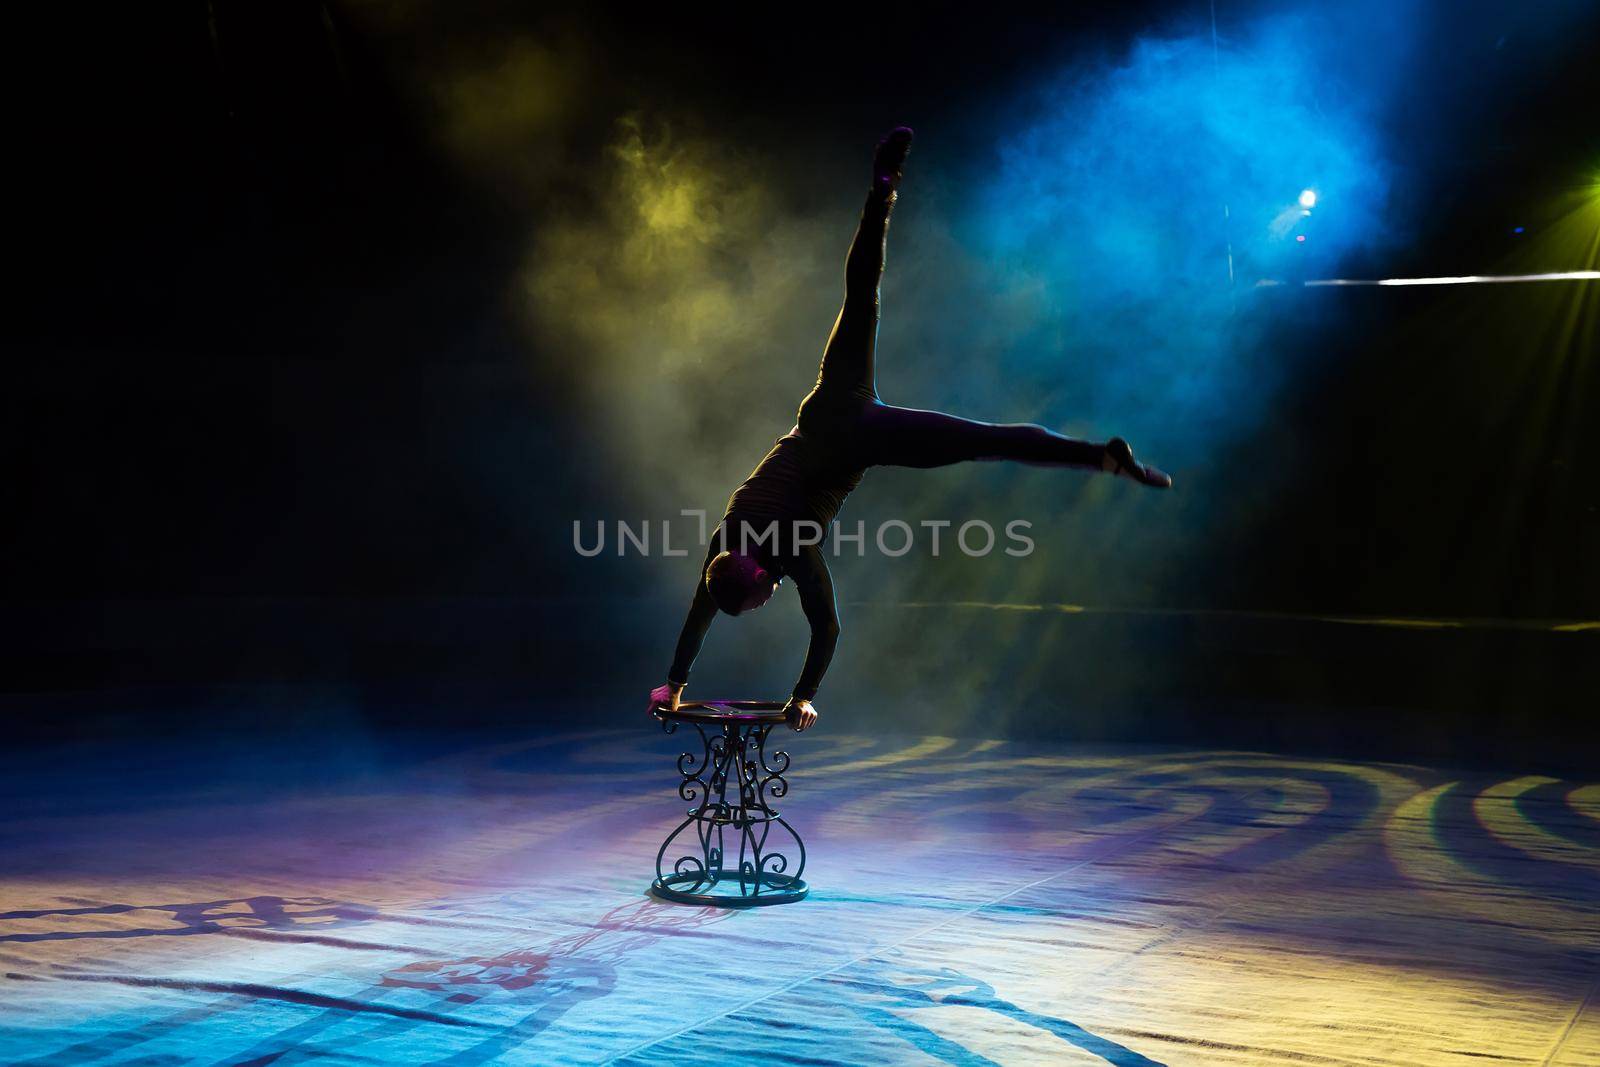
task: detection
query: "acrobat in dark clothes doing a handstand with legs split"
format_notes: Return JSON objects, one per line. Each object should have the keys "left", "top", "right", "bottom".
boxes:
{"left": 650, "top": 126, "right": 1173, "bottom": 729}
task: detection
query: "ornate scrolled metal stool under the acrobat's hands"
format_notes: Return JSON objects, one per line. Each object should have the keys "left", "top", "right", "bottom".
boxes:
{"left": 650, "top": 701, "right": 810, "bottom": 907}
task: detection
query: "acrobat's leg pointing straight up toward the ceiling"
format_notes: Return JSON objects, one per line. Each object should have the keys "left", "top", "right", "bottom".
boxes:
{"left": 806, "top": 126, "right": 912, "bottom": 403}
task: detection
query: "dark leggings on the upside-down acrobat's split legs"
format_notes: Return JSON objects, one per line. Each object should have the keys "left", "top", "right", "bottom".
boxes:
{"left": 798, "top": 194, "right": 1104, "bottom": 467}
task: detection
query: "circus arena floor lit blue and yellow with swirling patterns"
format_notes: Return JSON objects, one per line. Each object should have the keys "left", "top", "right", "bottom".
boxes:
{"left": 0, "top": 715, "right": 1600, "bottom": 1067}
